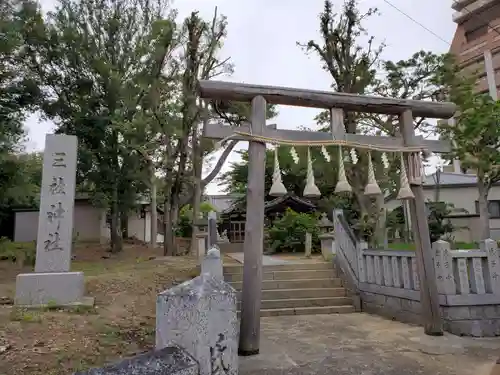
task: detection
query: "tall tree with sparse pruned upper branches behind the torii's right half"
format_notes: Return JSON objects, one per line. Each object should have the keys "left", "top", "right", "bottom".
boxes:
{"left": 299, "top": 0, "right": 450, "bottom": 242}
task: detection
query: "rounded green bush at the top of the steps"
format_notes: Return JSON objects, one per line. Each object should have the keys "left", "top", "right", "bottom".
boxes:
{"left": 267, "top": 209, "right": 321, "bottom": 253}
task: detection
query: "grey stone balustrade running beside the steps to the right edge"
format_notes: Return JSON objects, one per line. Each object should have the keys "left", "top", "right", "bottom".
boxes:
{"left": 334, "top": 211, "right": 500, "bottom": 336}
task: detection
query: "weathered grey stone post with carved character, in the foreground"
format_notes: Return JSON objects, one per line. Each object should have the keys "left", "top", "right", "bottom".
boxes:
{"left": 156, "top": 274, "right": 239, "bottom": 375}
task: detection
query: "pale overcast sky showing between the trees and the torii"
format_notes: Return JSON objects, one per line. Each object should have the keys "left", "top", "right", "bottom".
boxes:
{"left": 27, "top": 0, "right": 455, "bottom": 194}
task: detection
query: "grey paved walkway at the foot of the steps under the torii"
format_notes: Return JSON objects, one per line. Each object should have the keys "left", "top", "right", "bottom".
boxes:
{"left": 240, "top": 313, "right": 500, "bottom": 375}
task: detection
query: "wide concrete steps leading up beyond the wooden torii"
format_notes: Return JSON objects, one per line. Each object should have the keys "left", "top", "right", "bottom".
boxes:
{"left": 224, "top": 263, "right": 354, "bottom": 316}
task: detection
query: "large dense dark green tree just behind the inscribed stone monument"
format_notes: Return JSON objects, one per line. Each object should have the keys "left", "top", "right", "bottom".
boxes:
{"left": 20, "top": 0, "right": 175, "bottom": 251}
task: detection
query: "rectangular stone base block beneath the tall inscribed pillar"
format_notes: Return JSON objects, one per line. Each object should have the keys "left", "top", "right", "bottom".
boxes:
{"left": 14, "top": 272, "right": 93, "bottom": 307}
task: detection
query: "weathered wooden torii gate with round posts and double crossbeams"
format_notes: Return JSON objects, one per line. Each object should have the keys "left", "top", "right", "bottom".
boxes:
{"left": 199, "top": 81, "right": 456, "bottom": 355}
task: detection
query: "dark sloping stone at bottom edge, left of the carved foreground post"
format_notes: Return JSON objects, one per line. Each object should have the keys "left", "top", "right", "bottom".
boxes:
{"left": 74, "top": 346, "right": 198, "bottom": 375}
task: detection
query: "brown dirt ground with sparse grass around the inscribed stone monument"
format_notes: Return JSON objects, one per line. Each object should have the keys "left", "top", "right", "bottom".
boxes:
{"left": 0, "top": 244, "right": 199, "bottom": 375}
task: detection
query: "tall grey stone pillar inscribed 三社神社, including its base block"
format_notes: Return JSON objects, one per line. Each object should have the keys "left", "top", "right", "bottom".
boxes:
{"left": 15, "top": 134, "right": 93, "bottom": 306}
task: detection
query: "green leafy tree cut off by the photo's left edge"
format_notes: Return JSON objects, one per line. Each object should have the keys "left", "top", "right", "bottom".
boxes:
{"left": 0, "top": 0, "right": 41, "bottom": 225}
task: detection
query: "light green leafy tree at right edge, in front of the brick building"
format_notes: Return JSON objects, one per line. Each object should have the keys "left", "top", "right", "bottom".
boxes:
{"left": 437, "top": 56, "right": 500, "bottom": 239}
